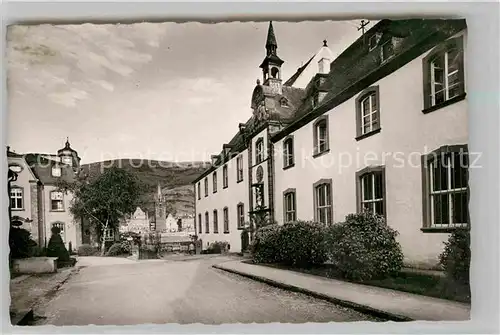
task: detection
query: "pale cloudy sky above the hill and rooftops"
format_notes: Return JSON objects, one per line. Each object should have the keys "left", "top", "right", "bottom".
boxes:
{"left": 7, "top": 20, "right": 372, "bottom": 163}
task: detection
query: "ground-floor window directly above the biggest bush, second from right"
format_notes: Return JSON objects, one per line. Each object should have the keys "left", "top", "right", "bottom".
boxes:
{"left": 360, "top": 171, "right": 385, "bottom": 215}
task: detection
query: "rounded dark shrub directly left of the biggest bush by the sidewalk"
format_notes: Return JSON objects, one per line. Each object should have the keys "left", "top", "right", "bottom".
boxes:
{"left": 278, "top": 221, "right": 327, "bottom": 267}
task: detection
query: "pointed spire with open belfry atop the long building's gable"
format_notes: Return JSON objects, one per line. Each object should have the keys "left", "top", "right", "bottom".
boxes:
{"left": 260, "top": 21, "right": 284, "bottom": 94}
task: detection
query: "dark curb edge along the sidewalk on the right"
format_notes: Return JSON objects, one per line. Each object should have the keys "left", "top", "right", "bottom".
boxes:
{"left": 212, "top": 265, "right": 415, "bottom": 322}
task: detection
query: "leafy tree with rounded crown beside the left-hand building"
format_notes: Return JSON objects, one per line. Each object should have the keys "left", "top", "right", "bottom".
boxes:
{"left": 58, "top": 167, "right": 144, "bottom": 255}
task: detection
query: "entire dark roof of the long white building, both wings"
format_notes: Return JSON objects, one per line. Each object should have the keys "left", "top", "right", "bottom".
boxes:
{"left": 193, "top": 19, "right": 466, "bottom": 183}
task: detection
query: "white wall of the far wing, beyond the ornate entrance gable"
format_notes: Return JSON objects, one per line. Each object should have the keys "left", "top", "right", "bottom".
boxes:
{"left": 196, "top": 150, "right": 250, "bottom": 252}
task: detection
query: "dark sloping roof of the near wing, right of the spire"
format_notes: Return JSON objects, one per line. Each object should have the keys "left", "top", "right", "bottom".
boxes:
{"left": 273, "top": 19, "right": 466, "bottom": 141}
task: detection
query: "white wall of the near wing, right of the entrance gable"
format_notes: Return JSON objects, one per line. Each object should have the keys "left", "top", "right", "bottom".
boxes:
{"left": 274, "top": 32, "right": 468, "bottom": 267}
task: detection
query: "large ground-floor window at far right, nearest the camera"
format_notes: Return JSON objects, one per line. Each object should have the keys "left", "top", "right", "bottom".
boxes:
{"left": 427, "top": 152, "right": 469, "bottom": 228}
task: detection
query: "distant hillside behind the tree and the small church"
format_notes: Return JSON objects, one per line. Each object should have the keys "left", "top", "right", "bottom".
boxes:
{"left": 82, "top": 159, "right": 210, "bottom": 215}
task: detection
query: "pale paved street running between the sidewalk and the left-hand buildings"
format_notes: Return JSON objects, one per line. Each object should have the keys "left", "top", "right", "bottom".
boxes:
{"left": 35, "top": 256, "right": 376, "bottom": 325}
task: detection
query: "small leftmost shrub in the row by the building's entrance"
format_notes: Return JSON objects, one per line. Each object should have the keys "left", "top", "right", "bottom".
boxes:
{"left": 250, "top": 224, "right": 282, "bottom": 263}
